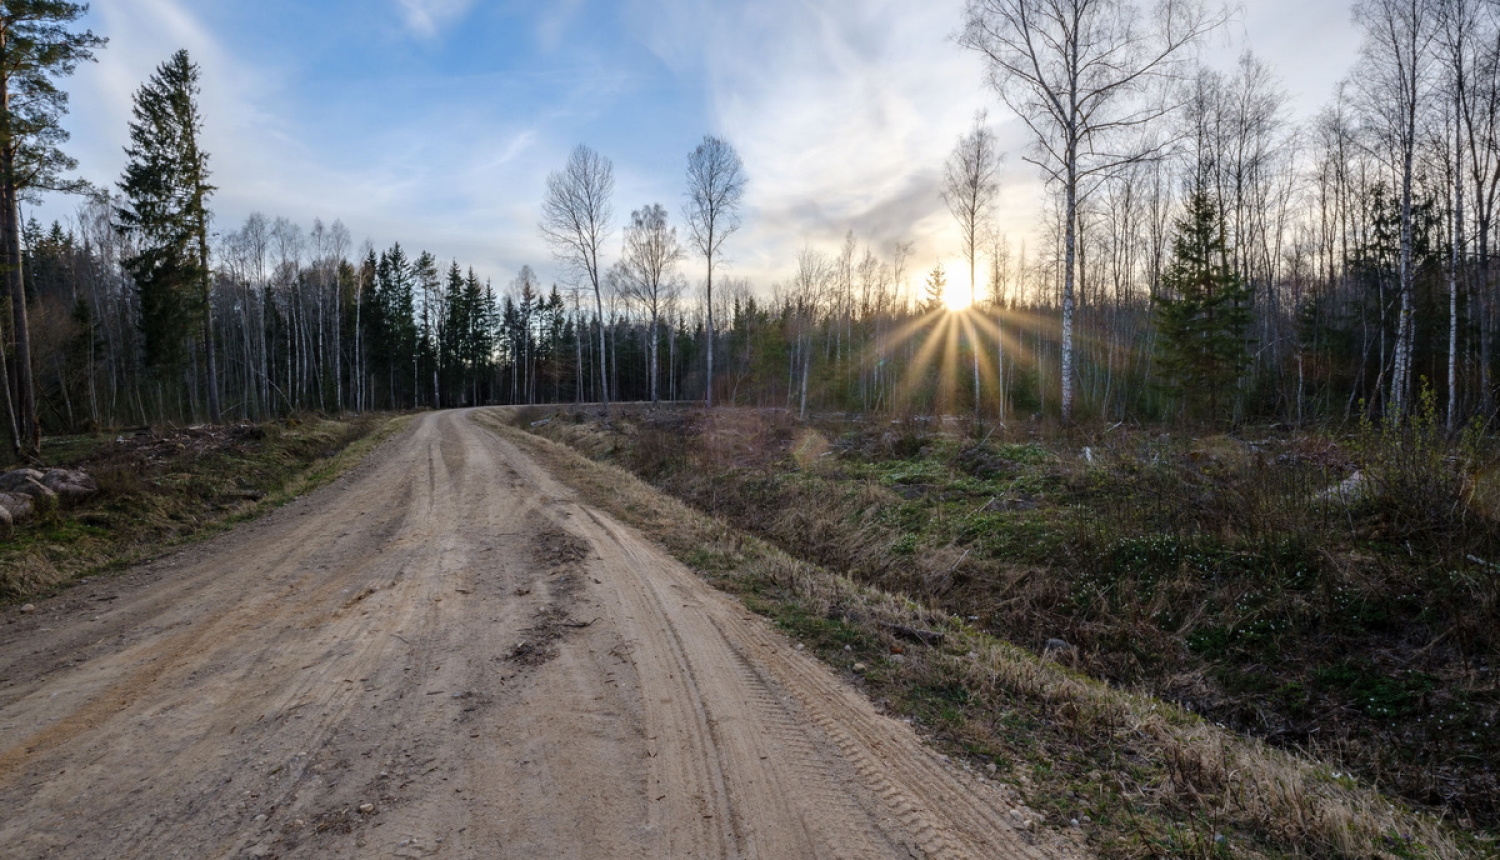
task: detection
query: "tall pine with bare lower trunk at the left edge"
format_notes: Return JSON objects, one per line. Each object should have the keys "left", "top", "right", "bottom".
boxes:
{"left": 0, "top": 0, "right": 105, "bottom": 456}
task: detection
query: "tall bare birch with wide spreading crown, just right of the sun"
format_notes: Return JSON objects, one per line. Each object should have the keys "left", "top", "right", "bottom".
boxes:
{"left": 960, "top": 0, "right": 1226, "bottom": 420}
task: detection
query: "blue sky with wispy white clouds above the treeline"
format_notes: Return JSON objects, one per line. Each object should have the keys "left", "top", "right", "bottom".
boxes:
{"left": 27, "top": 0, "right": 1358, "bottom": 298}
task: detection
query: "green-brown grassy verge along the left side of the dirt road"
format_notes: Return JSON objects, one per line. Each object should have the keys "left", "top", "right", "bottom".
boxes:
{"left": 0, "top": 416, "right": 405, "bottom": 602}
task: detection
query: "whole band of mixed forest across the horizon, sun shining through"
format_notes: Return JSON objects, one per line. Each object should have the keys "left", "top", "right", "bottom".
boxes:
{"left": 0, "top": 0, "right": 1500, "bottom": 453}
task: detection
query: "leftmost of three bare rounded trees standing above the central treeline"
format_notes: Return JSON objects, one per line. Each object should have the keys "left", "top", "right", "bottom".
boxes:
{"left": 542, "top": 144, "right": 615, "bottom": 410}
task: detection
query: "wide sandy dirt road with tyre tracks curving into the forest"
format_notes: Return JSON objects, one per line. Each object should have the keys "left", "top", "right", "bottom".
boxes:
{"left": 0, "top": 413, "right": 1080, "bottom": 860}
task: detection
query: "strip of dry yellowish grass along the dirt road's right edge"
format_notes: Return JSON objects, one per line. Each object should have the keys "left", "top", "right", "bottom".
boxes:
{"left": 489, "top": 410, "right": 1494, "bottom": 860}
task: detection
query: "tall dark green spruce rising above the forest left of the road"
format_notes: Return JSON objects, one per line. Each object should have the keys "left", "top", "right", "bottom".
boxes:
{"left": 119, "top": 51, "right": 219, "bottom": 423}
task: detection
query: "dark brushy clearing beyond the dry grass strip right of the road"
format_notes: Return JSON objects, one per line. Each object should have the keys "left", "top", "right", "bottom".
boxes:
{"left": 549, "top": 408, "right": 1500, "bottom": 831}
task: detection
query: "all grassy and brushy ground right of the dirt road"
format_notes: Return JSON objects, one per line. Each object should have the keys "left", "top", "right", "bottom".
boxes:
{"left": 512, "top": 405, "right": 1500, "bottom": 857}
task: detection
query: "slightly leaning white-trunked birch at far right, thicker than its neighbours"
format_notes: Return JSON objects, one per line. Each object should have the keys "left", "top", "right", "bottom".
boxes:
{"left": 1355, "top": 0, "right": 1439, "bottom": 420}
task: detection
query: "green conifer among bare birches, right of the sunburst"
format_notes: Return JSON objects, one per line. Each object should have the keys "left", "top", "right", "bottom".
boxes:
{"left": 1155, "top": 191, "right": 1250, "bottom": 419}
